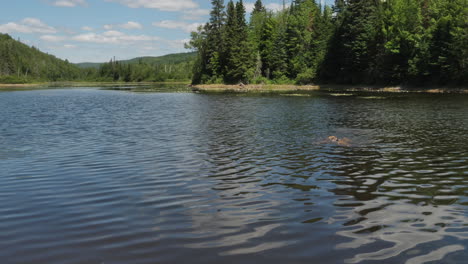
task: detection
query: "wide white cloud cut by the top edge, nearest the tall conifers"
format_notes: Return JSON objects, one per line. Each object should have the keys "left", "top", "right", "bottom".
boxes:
{"left": 106, "top": 0, "right": 198, "bottom": 11}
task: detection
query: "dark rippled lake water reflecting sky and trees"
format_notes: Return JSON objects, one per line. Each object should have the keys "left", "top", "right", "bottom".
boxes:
{"left": 0, "top": 88, "right": 468, "bottom": 264}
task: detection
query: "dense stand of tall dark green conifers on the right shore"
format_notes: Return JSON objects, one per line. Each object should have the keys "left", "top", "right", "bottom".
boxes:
{"left": 187, "top": 0, "right": 468, "bottom": 85}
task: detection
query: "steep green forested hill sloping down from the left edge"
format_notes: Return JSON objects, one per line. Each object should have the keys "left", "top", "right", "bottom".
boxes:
{"left": 0, "top": 34, "right": 83, "bottom": 83}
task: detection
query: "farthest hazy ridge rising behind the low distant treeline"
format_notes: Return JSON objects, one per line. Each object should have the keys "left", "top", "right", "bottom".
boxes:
{"left": 76, "top": 52, "right": 197, "bottom": 69}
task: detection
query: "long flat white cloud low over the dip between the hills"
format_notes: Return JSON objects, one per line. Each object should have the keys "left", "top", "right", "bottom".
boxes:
{"left": 72, "top": 30, "right": 160, "bottom": 44}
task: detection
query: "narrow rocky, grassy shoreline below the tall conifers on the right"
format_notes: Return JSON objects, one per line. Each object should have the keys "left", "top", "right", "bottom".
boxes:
{"left": 190, "top": 84, "right": 468, "bottom": 94}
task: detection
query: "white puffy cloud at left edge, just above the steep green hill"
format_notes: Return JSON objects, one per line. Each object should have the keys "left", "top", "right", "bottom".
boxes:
{"left": 0, "top": 18, "right": 57, "bottom": 34}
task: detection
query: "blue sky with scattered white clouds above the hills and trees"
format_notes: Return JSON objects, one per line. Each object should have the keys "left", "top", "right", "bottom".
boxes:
{"left": 0, "top": 0, "right": 330, "bottom": 62}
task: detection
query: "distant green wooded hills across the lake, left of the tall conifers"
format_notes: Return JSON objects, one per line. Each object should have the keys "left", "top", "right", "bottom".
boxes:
{"left": 0, "top": 34, "right": 196, "bottom": 83}
